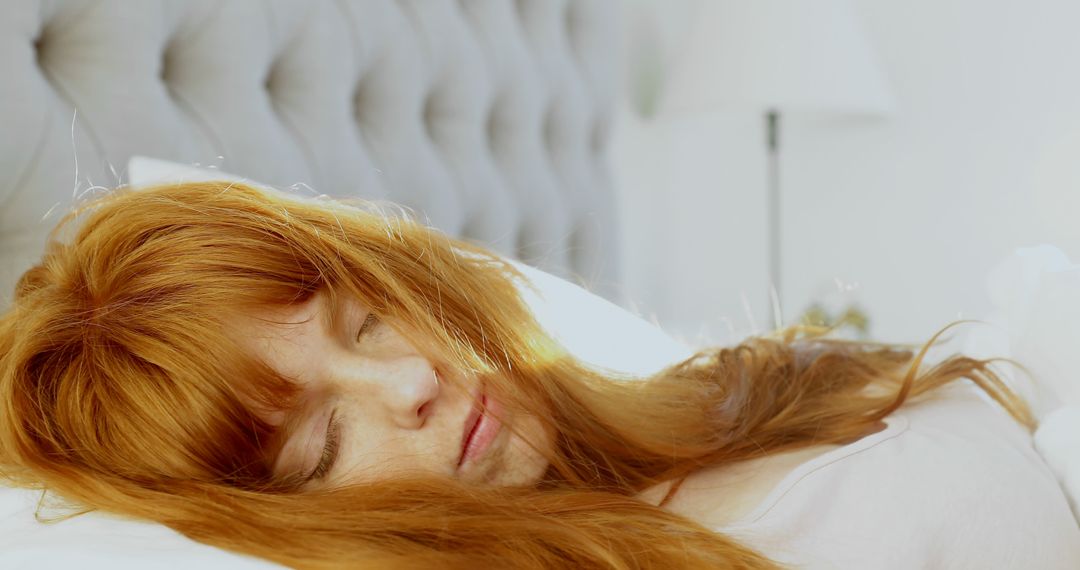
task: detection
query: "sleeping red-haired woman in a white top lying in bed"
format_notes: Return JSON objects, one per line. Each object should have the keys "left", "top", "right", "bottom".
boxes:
{"left": 0, "top": 182, "right": 1080, "bottom": 568}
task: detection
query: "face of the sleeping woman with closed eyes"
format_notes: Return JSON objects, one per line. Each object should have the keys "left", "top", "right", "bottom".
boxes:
{"left": 231, "top": 290, "right": 551, "bottom": 488}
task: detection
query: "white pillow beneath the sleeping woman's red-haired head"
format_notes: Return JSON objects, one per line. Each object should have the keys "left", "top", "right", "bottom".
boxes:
{"left": 0, "top": 157, "right": 691, "bottom": 570}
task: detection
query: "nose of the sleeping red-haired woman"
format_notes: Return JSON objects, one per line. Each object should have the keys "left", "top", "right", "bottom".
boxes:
{"left": 373, "top": 356, "right": 441, "bottom": 430}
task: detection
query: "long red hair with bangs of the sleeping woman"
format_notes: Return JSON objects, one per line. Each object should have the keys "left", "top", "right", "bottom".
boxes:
{"left": 0, "top": 182, "right": 1032, "bottom": 569}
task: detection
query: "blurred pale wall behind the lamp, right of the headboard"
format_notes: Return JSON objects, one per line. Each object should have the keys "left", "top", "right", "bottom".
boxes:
{"left": 612, "top": 0, "right": 1080, "bottom": 342}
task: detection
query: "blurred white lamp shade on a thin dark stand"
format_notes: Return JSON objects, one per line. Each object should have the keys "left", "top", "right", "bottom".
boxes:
{"left": 661, "top": 0, "right": 894, "bottom": 116}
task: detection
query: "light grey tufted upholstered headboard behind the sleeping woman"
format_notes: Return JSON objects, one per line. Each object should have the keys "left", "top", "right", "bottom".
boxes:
{"left": 0, "top": 0, "right": 619, "bottom": 307}
